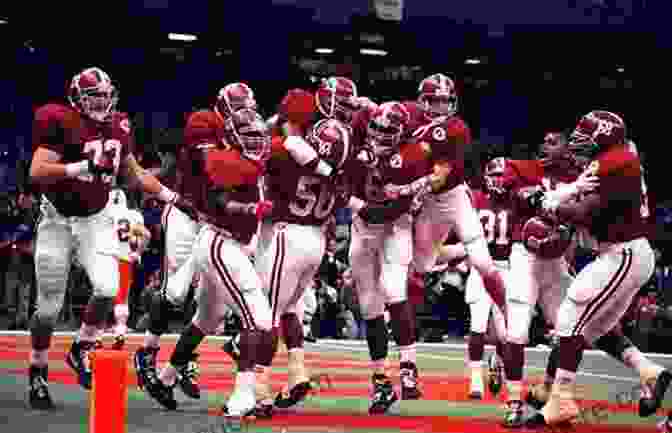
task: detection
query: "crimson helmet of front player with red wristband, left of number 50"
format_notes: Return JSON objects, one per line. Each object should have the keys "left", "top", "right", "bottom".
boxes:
{"left": 227, "top": 108, "right": 271, "bottom": 162}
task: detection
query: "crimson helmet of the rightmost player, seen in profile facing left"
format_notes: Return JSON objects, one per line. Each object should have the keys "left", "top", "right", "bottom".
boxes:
{"left": 569, "top": 110, "right": 625, "bottom": 159}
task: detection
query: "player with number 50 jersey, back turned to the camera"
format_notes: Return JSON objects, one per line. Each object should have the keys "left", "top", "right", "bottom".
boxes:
{"left": 255, "top": 119, "right": 350, "bottom": 413}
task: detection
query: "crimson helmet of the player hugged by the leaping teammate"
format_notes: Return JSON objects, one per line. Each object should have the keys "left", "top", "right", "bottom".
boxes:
{"left": 366, "top": 101, "right": 411, "bottom": 156}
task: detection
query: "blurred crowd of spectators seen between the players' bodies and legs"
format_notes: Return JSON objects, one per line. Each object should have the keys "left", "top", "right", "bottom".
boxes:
{"left": 0, "top": 147, "right": 672, "bottom": 352}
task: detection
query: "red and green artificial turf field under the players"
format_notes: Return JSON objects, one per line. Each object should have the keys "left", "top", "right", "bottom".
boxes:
{"left": 0, "top": 332, "right": 672, "bottom": 433}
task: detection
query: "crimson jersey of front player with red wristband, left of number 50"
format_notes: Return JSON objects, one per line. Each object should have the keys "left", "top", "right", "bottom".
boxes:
{"left": 200, "top": 149, "right": 263, "bottom": 244}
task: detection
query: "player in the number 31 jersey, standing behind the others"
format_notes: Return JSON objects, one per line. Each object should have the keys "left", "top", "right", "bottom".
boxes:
{"left": 465, "top": 157, "right": 516, "bottom": 399}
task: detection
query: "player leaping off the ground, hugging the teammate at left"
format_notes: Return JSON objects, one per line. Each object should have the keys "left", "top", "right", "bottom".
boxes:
{"left": 385, "top": 74, "right": 505, "bottom": 358}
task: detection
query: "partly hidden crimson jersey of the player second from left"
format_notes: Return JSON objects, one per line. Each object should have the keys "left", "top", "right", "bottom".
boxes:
{"left": 177, "top": 110, "right": 225, "bottom": 201}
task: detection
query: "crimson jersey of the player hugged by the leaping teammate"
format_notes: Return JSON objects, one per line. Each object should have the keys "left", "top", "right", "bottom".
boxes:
{"left": 350, "top": 143, "right": 431, "bottom": 203}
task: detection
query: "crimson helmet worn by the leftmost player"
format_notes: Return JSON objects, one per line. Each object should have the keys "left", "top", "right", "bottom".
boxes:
{"left": 68, "top": 68, "right": 119, "bottom": 122}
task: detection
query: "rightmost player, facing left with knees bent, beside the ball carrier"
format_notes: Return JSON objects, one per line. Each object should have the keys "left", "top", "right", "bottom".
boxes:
{"left": 530, "top": 110, "right": 655, "bottom": 425}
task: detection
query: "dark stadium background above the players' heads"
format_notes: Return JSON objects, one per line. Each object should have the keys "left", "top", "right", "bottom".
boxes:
{"left": 0, "top": 0, "right": 672, "bottom": 197}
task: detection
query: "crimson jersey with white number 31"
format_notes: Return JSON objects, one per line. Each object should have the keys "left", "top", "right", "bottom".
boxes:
{"left": 471, "top": 190, "right": 520, "bottom": 261}
